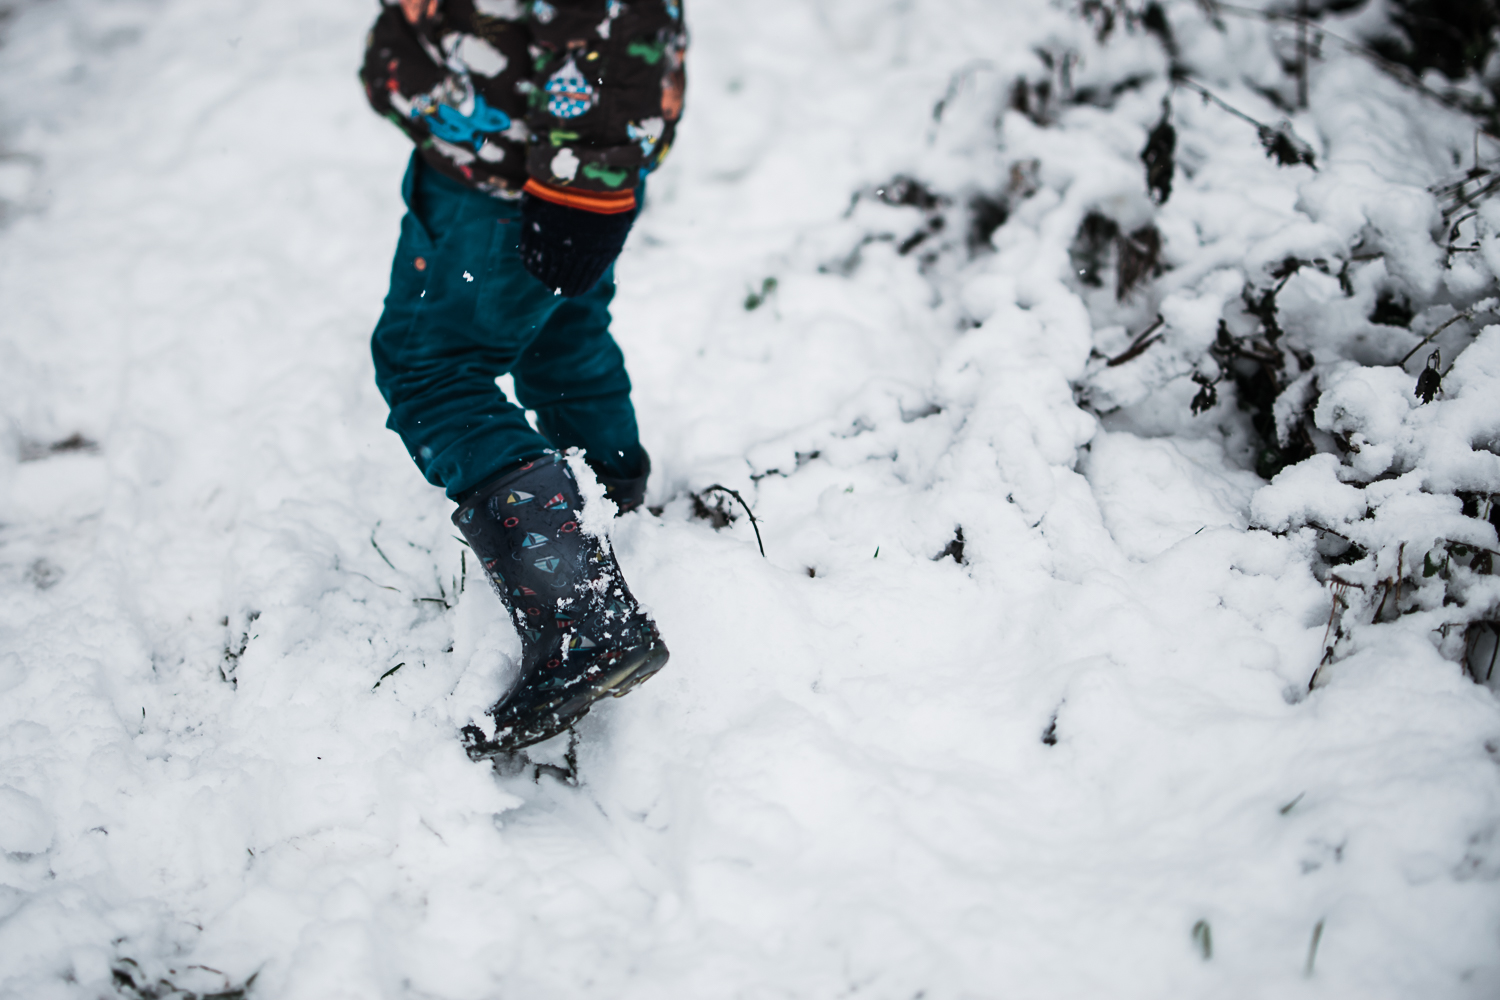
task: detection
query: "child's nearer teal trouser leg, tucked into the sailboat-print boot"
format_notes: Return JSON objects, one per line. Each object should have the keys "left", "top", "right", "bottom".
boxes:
{"left": 371, "top": 156, "right": 564, "bottom": 498}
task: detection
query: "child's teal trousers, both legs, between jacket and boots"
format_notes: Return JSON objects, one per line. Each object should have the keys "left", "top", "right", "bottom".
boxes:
{"left": 371, "top": 153, "right": 645, "bottom": 499}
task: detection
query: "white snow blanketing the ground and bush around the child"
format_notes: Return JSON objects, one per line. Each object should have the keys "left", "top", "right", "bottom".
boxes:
{"left": 0, "top": 0, "right": 1500, "bottom": 1000}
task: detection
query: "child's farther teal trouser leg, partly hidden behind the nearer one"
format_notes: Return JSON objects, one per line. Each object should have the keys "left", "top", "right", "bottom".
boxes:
{"left": 513, "top": 268, "right": 645, "bottom": 478}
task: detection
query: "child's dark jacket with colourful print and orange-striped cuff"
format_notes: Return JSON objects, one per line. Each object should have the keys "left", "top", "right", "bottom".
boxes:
{"left": 360, "top": 0, "right": 687, "bottom": 213}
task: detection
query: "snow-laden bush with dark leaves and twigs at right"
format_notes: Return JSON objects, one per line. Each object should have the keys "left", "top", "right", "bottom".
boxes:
{"left": 824, "top": 0, "right": 1500, "bottom": 684}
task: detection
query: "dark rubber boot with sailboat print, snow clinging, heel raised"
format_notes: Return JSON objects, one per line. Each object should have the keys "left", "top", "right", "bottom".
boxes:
{"left": 453, "top": 454, "right": 669, "bottom": 760}
